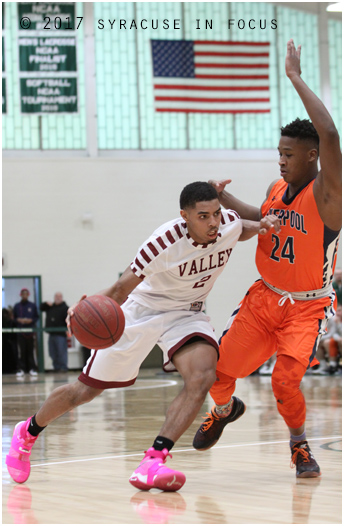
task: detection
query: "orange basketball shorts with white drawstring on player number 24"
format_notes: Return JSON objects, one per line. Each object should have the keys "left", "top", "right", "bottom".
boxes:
{"left": 217, "top": 280, "right": 334, "bottom": 378}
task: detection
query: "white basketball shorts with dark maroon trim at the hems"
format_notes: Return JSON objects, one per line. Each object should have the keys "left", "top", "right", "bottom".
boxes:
{"left": 79, "top": 299, "right": 219, "bottom": 389}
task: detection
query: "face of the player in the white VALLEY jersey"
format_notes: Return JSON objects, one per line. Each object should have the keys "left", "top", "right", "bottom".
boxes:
{"left": 180, "top": 199, "right": 221, "bottom": 244}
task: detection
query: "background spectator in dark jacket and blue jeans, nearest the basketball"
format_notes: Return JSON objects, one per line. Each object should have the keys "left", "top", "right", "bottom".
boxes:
{"left": 41, "top": 292, "right": 68, "bottom": 371}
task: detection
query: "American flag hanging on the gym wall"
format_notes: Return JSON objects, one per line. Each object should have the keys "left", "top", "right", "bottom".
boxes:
{"left": 151, "top": 40, "right": 270, "bottom": 113}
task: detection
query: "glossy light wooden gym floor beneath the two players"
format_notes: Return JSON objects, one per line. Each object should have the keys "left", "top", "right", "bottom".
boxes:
{"left": 2, "top": 369, "right": 342, "bottom": 524}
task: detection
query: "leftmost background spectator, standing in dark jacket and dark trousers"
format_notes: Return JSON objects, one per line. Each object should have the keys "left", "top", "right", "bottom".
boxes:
{"left": 13, "top": 288, "right": 39, "bottom": 377}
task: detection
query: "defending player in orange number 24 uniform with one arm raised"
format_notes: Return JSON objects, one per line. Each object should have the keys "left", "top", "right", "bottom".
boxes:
{"left": 193, "top": 40, "right": 342, "bottom": 477}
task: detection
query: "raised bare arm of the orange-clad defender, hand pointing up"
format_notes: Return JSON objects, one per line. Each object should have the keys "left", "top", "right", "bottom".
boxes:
{"left": 285, "top": 39, "right": 342, "bottom": 230}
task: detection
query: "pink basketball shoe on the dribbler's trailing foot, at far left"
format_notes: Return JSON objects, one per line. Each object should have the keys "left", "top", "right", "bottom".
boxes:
{"left": 6, "top": 416, "right": 37, "bottom": 484}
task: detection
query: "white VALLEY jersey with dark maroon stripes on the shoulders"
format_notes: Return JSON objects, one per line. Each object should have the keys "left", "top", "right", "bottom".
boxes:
{"left": 130, "top": 210, "right": 243, "bottom": 311}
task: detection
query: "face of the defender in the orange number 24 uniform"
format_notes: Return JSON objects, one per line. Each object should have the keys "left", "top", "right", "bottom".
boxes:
{"left": 278, "top": 137, "right": 317, "bottom": 186}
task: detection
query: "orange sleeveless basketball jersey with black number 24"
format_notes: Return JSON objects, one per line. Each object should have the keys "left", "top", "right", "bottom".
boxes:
{"left": 256, "top": 179, "right": 339, "bottom": 292}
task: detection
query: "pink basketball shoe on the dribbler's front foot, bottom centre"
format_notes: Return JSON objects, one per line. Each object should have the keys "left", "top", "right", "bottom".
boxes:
{"left": 129, "top": 447, "right": 185, "bottom": 491}
